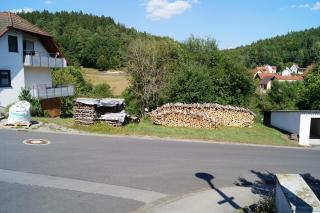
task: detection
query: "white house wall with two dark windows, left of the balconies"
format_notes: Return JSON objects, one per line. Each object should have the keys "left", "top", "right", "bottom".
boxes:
{"left": 0, "top": 31, "right": 25, "bottom": 107}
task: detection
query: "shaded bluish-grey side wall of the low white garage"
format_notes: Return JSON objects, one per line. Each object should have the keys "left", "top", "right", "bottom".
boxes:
{"left": 271, "top": 111, "right": 301, "bottom": 134}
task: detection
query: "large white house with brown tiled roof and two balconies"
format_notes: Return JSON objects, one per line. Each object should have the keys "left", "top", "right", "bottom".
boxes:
{"left": 0, "top": 12, "right": 74, "bottom": 110}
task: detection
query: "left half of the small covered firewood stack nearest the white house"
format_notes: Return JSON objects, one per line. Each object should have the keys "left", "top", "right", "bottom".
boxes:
{"left": 73, "top": 102, "right": 98, "bottom": 125}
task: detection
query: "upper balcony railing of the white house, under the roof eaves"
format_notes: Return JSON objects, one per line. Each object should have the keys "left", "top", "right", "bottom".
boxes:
{"left": 24, "top": 51, "right": 67, "bottom": 68}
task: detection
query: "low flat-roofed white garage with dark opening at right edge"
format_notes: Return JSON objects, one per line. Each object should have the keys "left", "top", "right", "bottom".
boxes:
{"left": 270, "top": 111, "right": 320, "bottom": 146}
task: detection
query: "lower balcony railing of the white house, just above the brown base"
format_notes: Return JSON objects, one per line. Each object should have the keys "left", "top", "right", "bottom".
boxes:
{"left": 28, "top": 85, "right": 74, "bottom": 100}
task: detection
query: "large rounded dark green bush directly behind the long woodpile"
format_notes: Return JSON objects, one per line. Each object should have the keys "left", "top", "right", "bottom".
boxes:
{"left": 166, "top": 59, "right": 254, "bottom": 107}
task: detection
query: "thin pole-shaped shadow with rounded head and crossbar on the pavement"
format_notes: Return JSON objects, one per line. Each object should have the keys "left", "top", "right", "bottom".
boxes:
{"left": 195, "top": 172, "right": 241, "bottom": 209}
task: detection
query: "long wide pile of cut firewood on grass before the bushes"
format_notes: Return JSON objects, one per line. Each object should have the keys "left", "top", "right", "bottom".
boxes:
{"left": 150, "top": 103, "right": 255, "bottom": 128}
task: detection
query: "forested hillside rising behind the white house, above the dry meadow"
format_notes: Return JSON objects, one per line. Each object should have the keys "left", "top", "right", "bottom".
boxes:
{"left": 19, "top": 11, "right": 168, "bottom": 69}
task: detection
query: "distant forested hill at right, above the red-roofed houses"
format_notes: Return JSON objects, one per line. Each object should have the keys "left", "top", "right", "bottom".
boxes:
{"left": 225, "top": 27, "right": 320, "bottom": 69}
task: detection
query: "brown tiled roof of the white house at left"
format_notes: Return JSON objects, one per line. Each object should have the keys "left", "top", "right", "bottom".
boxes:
{"left": 0, "top": 12, "right": 51, "bottom": 37}
